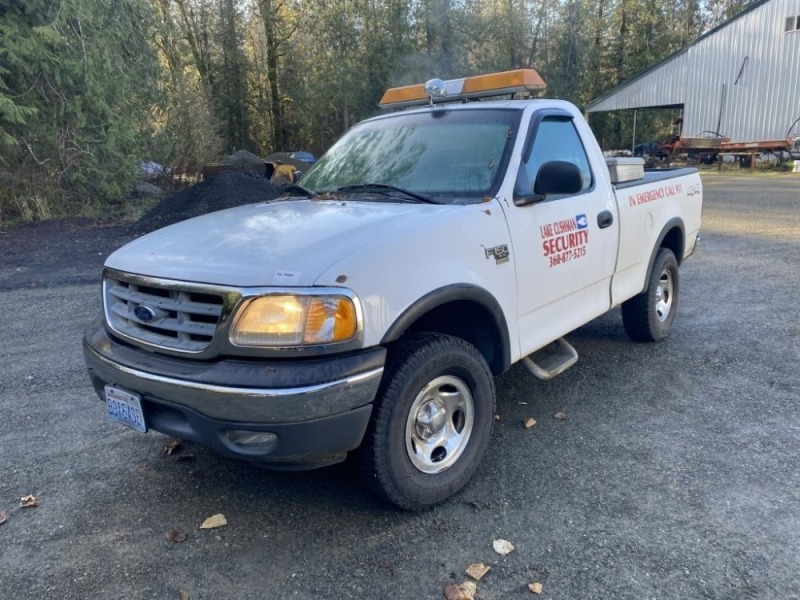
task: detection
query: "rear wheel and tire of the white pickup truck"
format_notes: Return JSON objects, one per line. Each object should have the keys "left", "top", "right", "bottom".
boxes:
{"left": 622, "top": 248, "right": 680, "bottom": 342}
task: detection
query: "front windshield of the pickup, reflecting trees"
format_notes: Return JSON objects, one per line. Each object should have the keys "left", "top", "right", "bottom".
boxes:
{"left": 301, "top": 109, "right": 521, "bottom": 198}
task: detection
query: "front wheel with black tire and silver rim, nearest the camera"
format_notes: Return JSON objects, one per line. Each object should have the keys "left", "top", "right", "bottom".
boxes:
{"left": 362, "top": 333, "right": 495, "bottom": 510}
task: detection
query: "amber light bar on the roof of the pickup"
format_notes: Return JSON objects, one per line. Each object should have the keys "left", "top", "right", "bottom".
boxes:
{"left": 380, "top": 69, "right": 547, "bottom": 108}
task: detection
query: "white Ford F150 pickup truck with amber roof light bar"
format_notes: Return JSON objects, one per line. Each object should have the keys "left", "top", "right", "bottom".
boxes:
{"left": 84, "top": 69, "right": 702, "bottom": 509}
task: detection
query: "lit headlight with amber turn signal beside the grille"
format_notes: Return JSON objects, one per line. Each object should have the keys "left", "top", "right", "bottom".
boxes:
{"left": 230, "top": 295, "right": 358, "bottom": 346}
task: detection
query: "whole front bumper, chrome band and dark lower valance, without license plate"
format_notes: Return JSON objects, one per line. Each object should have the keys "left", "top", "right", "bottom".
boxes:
{"left": 83, "top": 322, "right": 386, "bottom": 469}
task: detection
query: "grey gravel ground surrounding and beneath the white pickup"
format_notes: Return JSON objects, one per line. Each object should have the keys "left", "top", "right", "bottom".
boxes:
{"left": 0, "top": 176, "right": 800, "bottom": 600}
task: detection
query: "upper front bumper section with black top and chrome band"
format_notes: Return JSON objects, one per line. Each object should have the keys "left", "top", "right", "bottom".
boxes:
{"left": 83, "top": 325, "right": 385, "bottom": 424}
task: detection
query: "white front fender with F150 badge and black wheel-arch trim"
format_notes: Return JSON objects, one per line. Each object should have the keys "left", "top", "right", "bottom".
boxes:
{"left": 315, "top": 199, "right": 519, "bottom": 364}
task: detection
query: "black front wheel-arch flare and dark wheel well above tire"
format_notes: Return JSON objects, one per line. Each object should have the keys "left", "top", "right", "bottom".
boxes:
{"left": 381, "top": 284, "right": 511, "bottom": 375}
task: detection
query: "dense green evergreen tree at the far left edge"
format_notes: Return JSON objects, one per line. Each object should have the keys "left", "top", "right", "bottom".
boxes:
{"left": 0, "top": 0, "right": 157, "bottom": 219}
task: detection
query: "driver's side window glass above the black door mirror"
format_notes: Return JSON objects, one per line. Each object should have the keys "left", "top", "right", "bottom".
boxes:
{"left": 525, "top": 117, "right": 592, "bottom": 190}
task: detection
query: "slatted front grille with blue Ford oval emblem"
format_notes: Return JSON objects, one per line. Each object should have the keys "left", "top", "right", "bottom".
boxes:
{"left": 103, "top": 277, "right": 224, "bottom": 352}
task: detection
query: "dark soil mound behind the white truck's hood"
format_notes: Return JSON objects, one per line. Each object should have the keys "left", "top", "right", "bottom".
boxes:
{"left": 134, "top": 171, "right": 280, "bottom": 233}
